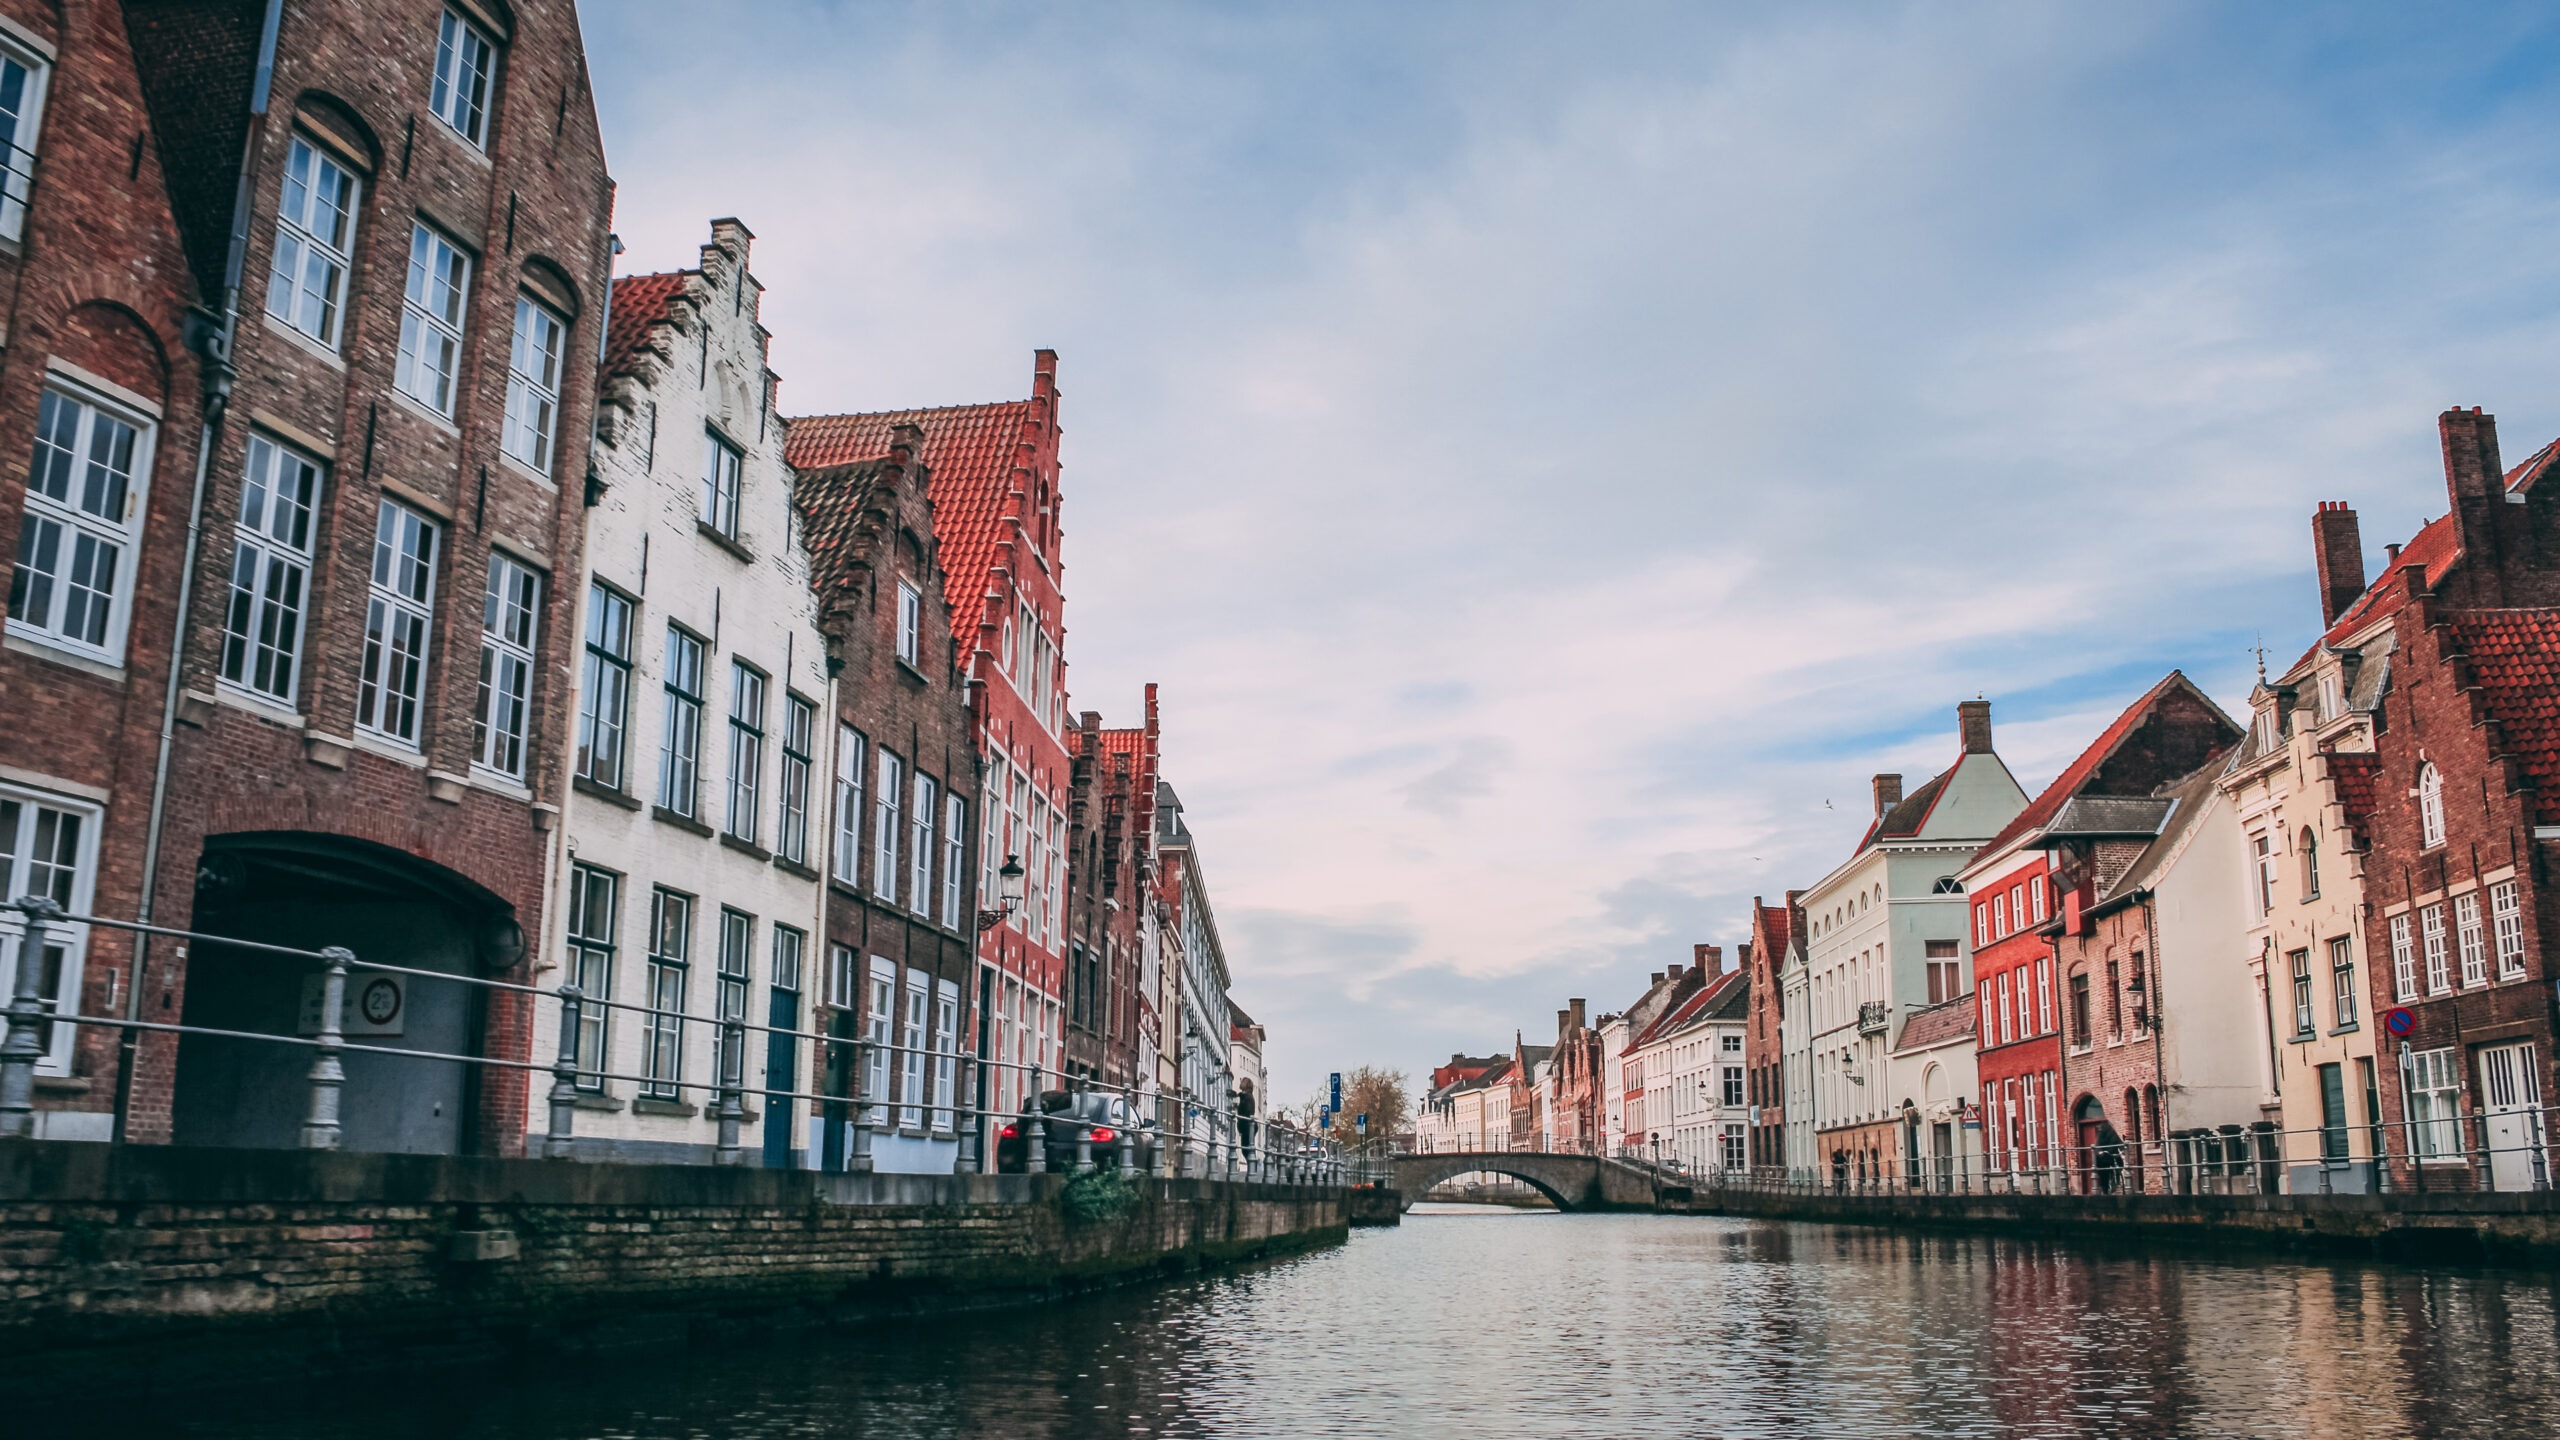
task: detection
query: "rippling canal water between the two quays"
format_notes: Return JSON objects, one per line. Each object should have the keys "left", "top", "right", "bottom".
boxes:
{"left": 80, "top": 1207, "right": 2560, "bottom": 1440}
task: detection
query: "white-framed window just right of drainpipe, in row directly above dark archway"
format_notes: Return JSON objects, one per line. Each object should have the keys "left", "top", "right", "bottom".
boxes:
{"left": 223, "top": 433, "right": 320, "bottom": 705}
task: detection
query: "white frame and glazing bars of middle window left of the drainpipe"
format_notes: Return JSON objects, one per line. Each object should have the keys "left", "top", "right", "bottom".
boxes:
{"left": 8, "top": 374, "right": 159, "bottom": 666}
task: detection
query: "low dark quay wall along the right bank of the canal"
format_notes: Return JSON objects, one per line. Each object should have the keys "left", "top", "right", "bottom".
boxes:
{"left": 1664, "top": 1186, "right": 2560, "bottom": 1266}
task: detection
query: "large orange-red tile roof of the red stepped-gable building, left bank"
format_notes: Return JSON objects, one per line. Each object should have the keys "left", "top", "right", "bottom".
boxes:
{"left": 783, "top": 400, "right": 1032, "bottom": 666}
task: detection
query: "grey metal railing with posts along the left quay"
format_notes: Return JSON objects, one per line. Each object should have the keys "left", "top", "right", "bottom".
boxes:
{"left": 0, "top": 897, "right": 1375, "bottom": 1184}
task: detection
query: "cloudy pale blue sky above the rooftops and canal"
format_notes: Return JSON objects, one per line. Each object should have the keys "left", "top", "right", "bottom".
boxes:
{"left": 584, "top": 0, "right": 2560, "bottom": 1102}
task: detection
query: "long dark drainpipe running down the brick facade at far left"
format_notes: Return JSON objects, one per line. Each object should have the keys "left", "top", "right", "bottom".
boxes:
{"left": 115, "top": 0, "right": 284, "bottom": 1143}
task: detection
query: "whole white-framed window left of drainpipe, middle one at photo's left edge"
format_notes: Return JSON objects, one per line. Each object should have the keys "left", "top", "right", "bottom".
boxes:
{"left": 8, "top": 387, "right": 151, "bottom": 653}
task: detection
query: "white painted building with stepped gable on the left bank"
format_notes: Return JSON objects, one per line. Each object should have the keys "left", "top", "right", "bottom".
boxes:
{"left": 530, "top": 220, "right": 835, "bottom": 1166}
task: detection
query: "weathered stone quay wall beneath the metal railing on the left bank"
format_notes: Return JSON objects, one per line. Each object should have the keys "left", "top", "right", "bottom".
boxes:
{"left": 0, "top": 1140, "right": 1352, "bottom": 1376}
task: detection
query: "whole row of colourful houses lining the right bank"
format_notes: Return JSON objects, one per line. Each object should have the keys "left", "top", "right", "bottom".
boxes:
{"left": 1418, "top": 397, "right": 2560, "bottom": 1191}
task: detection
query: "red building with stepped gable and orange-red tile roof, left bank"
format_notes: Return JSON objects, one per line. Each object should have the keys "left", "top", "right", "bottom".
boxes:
{"left": 788, "top": 351, "right": 1080, "bottom": 1112}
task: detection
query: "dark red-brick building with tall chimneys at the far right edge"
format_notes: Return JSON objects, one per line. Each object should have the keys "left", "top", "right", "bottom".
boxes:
{"left": 2332, "top": 410, "right": 2560, "bottom": 1189}
